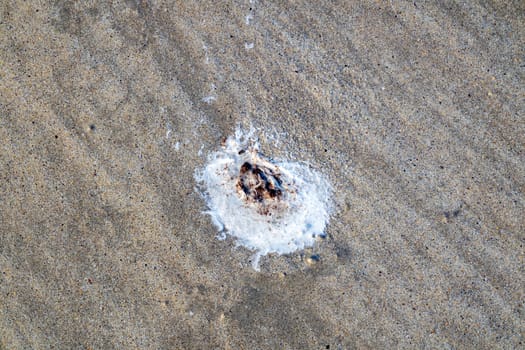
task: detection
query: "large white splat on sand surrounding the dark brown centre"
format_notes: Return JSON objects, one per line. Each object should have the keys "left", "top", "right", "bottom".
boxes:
{"left": 195, "top": 129, "right": 332, "bottom": 270}
